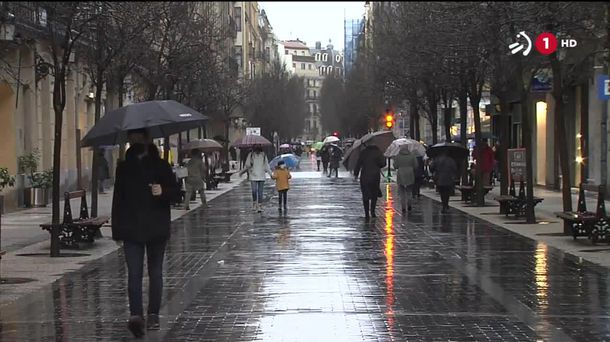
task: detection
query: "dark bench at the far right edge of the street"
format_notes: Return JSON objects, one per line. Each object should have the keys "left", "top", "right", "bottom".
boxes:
{"left": 555, "top": 184, "right": 610, "bottom": 244}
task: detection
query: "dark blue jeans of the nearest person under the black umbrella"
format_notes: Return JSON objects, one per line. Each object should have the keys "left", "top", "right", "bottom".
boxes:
{"left": 123, "top": 240, "right": 167, "bottom": 316}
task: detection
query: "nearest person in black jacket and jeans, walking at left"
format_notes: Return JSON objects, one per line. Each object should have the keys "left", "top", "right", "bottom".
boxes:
{"left": 112, "top": 130, "right": 179, "bottom": 337}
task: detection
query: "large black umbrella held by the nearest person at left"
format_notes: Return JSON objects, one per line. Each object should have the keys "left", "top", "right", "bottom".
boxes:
{"left": 81, "top": 100, "right": 208, "bottom": 147}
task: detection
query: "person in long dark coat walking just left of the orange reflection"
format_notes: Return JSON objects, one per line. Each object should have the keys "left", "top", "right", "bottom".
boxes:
{"left": 354, "top": 143, "right": 386, "bottom": 220}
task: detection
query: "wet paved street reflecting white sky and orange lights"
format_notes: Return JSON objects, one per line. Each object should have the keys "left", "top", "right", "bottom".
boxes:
{"left": 0, "top": 159, "right": 610, "bottom": 341}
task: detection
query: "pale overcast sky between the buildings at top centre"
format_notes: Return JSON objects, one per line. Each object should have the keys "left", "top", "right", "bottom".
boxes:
{"left": 259, "top": 1, "right": 364, "bottom": 50}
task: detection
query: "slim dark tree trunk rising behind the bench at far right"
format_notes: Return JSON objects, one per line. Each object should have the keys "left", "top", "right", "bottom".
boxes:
{"left": 550, "top": 53, "right": 572, "bottom": 211}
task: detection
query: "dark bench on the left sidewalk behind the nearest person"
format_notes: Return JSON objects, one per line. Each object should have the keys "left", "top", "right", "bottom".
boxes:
{"left": 40, "top": 190, "right": 110, "bottom": 248}
